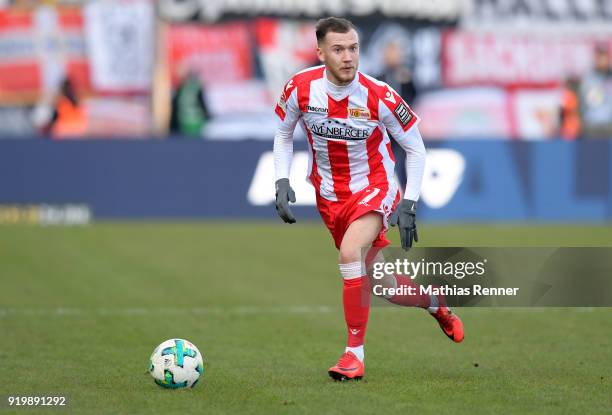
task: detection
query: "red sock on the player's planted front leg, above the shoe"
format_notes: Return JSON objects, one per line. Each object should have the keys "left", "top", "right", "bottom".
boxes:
{"left": 342, "top": 276, "right": 370, "bottom": 347}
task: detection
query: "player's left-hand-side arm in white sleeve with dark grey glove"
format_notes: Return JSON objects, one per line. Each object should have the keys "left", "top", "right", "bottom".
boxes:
{"left": 274, "top": 81, "right": 301, "bottom": 223}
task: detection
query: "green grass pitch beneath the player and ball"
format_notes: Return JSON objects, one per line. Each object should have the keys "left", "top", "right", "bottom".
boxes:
{"left": 0, "top": 226, "right": 612, "bottom": 414}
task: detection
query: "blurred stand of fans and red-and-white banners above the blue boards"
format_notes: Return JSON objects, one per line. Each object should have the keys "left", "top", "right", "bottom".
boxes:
{"left": 0, "top": 0, "right": 612, "bottom": 140}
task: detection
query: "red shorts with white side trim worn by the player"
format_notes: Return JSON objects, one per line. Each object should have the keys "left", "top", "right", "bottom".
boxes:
{"left": 317, "top": 185, "right": 400, "bottom": 249}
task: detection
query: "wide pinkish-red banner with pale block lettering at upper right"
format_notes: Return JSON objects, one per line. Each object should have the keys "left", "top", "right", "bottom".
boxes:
{"left": 442, "top": 30, "right": 612, "bottom": 87}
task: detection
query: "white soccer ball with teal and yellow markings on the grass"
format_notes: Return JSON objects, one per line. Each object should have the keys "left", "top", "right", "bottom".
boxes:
{"left": 149, "top": 339, "right": 204, "bottom": 389}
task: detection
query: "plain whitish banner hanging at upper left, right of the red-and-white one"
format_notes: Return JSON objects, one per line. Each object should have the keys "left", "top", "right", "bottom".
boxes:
{"left": 84, "top": 0, "right": 155, "bottom": 93}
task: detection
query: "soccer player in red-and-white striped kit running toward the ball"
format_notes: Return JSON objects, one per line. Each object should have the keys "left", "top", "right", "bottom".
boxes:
{"left": 274, "top": 17, "right": 463, "bottom": 380}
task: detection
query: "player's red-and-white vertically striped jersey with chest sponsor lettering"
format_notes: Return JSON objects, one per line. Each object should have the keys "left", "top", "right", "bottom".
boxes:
{"left": 275, "top": 66, "right": 424, "bottom": 201}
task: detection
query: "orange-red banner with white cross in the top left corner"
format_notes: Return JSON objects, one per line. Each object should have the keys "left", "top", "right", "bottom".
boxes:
{"left": 0, "top": 7, "right": 89, "bottom": 105}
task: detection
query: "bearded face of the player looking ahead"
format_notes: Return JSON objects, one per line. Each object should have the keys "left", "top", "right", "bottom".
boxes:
{"left": 317, "top": 29, "right": 359, "bottom": 85}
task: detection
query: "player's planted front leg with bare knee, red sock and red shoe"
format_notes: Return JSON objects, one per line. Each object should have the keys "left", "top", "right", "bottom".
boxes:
{"left": 329, "top": 212, "right": 382, "bottom": 380}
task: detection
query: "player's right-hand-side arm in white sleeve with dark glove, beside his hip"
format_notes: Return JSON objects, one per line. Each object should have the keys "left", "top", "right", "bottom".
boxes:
{"left": 379, "top": 88, "right": 426, "bottom": 250}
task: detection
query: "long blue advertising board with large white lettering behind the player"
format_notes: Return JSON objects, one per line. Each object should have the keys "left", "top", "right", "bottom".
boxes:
{"left": 0, "top": 139, "right": 612, "bottom": 223}
